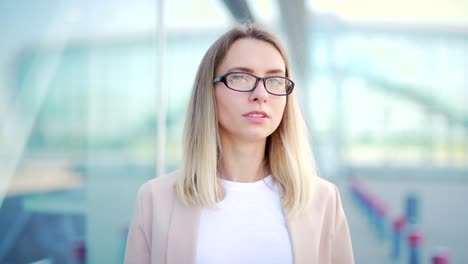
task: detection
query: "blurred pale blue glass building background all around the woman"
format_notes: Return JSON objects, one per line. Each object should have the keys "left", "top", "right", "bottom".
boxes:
{"left": 0, "top": 0, "right": 468, "bottom": 263}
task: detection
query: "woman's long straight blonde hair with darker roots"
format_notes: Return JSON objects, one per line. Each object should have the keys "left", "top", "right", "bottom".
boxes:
{"left": 175, "top": 22, "right": 317, "bottom": 216}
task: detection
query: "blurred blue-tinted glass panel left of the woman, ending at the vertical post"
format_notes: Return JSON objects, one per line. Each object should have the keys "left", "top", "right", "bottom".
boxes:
{"left": 0, "top": 1, "right": 159, "bottom": 263}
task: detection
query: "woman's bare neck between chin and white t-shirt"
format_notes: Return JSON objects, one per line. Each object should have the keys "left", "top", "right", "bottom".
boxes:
{"left": 221, "top": 136, "right": 268, "bottom": 182}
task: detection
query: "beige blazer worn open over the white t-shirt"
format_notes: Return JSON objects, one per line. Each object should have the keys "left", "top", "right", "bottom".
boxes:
{"left": 125, "top": 172, "right": 354, "bottom": 264}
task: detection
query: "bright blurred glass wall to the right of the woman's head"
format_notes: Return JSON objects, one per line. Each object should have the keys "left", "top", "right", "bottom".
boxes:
{"left": 309, "top": 26, "right": 468, "bottom": 167}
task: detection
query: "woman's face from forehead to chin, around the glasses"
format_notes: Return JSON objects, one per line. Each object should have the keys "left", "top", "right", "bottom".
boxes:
{"left": 215, "top": 38, "right": 286, "bottom": 141}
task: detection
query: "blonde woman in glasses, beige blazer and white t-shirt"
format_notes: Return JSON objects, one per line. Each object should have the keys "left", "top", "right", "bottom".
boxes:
{"left": 125, "top": 25, "right": 354, "bottom": 264}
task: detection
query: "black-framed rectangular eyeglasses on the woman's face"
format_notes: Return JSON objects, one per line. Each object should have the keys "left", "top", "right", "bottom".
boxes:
{"left": 213, "top": 72, "right": 294, "bottom": 96}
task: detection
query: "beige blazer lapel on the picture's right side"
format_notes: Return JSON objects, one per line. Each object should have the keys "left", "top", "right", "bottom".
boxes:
{"left": 286, "top": 209, "right": 318, "bottom": 264}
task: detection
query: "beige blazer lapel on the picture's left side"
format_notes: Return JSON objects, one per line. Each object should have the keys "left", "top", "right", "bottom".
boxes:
{"left": 167, "top": 198, "right": 200, "bottom": 264}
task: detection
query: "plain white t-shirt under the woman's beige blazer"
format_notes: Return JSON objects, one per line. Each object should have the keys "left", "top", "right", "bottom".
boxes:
{"left": 197, "top": 176, "right": 293, "bottom": 264}
